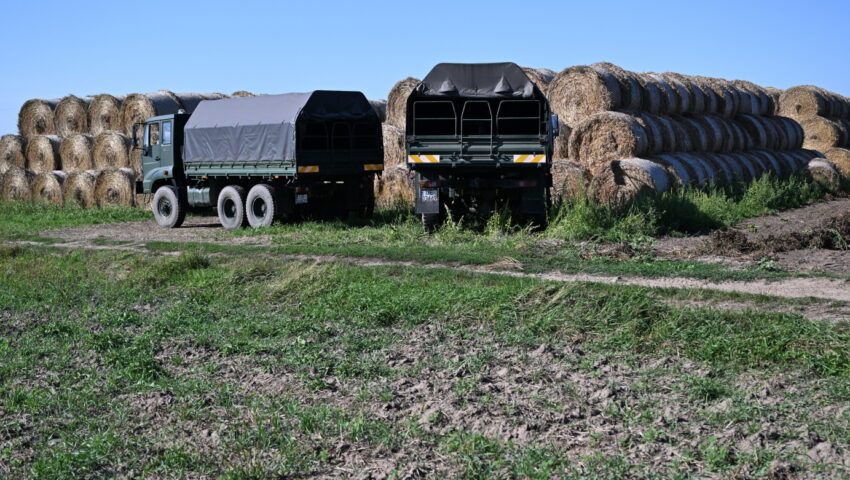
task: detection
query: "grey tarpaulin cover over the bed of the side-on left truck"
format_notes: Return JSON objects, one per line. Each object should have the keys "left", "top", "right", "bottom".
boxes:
{"left": 183, "top": 90, "right": 379, "bottom": 163}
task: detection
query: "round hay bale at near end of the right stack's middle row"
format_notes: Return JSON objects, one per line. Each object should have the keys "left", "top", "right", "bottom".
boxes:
{"left": 569, "top": 112, "right": 649, "bottom": 171}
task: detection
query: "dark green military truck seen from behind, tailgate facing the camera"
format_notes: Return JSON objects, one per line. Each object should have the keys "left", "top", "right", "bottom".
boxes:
{"left": 405, "top": 63, "right": 559, "bottom": 231}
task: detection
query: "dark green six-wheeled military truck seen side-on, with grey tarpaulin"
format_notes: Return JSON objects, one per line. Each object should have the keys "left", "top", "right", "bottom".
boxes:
{"left": 133, "top": 90, "right": 383, "bottom": 229}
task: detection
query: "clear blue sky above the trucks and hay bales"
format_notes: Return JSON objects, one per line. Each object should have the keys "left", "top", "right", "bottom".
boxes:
{"left": 0, "top": 0, "right": 850, "bottom": 133}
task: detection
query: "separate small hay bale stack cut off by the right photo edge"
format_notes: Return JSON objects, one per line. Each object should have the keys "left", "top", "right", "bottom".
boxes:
{"left": 779, "top": 85, "right": 850, "bottom": 176}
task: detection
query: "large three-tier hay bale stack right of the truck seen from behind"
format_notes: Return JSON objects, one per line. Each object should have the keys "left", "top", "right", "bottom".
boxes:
{"left": 548, "top": 63, "right": 840, "bottom": 204}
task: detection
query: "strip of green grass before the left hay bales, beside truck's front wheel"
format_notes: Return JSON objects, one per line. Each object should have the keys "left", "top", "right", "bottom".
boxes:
{"left": 0, "top": 202, "right": 153, "bottom": 238}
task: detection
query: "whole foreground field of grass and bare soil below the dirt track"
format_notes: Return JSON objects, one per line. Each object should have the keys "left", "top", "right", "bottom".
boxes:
{"left": 0, "top": 247, "right": 850, "bottom": 478}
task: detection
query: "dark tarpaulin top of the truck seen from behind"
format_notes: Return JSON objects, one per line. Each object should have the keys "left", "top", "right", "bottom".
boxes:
{"left": 412, "top": 62, "right": 537, "bottom": 98}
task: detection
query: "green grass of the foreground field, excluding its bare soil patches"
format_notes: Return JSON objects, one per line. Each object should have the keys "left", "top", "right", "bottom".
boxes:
{"left": 0, "top": 247, "right": 850, "bottom": 478}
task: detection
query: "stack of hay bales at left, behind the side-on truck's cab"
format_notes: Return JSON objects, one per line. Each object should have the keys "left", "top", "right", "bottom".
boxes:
{"left": 0, "top": 90, "right": 234, "bottom": 208}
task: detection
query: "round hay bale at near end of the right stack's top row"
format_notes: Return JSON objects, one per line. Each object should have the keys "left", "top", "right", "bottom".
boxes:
{"left": 548, "top": 65, "right": 622, "bottom": 128}
